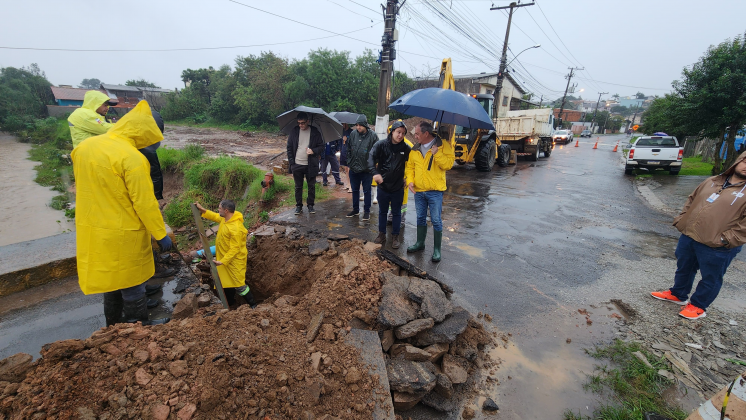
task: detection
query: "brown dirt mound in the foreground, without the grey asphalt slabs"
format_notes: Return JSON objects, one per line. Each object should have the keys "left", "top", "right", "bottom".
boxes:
{"left": 0, "top": 235, "right": 391, "bottom": 420}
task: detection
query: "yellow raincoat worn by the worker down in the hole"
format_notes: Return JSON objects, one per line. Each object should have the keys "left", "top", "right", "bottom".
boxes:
{"left": 202, "top": 210, "right": 249, "bottom": 287}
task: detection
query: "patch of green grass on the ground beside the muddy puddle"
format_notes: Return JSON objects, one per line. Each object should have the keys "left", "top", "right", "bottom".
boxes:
{"left": 564, "top": 339, "right": 687, "bottom": 420}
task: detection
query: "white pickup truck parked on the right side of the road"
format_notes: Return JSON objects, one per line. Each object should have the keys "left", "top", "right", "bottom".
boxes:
{"left": 624, "top": 136, "right": 684, "bottom": 175}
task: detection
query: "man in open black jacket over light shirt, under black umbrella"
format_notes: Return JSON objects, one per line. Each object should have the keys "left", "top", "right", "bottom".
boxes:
{"left": 287, "top": 112, "right": 324, "bottom": 214}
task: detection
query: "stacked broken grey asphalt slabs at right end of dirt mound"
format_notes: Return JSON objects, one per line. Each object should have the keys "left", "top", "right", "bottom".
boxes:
{"left": 374, "top": 272, "right": 493, "bottom": 412}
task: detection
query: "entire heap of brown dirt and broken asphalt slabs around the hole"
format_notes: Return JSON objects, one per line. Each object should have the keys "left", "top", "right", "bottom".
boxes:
{"left": 0, "top": 226, "right": 495, "bottom": 420}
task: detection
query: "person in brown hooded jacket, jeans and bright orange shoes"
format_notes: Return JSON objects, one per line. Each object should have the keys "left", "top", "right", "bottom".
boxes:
{"left": 651, "top": 153, "right": 746, "bottom": 319}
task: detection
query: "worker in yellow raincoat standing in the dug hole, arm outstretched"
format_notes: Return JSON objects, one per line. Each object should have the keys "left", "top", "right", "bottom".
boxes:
{"left": 194, "top": 200, "right": 256, "bottom": 308}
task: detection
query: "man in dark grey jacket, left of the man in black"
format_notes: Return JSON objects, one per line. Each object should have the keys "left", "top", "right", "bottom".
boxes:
{"left": 346, "top": 114, "right": 378, "bottom": 220}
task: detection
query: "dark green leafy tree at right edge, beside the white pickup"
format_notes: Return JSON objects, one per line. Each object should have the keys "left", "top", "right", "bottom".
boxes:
{"left": 642, "top": 30, "right": 746, "bottom": 175}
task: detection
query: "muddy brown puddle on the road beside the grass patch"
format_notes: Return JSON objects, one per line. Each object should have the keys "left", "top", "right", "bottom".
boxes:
{"left": 486, "top": 304, "right": 622, "bottom": 420}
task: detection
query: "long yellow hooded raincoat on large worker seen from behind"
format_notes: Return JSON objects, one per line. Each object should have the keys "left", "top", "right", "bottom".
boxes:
{"left": 71, "top": 101, "right": 166, "bottom": 295}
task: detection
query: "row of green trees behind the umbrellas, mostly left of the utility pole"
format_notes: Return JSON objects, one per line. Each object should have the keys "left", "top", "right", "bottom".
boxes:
{"left": 161, "top": 49, "right": 415, "bottom": 130}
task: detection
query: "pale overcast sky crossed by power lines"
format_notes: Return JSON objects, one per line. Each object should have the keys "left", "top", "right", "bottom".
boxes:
{"left": 0, "top": 0, "right": 746, "bottom": 99}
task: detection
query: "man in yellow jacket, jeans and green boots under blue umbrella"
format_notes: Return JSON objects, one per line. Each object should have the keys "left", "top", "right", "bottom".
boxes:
{"left": 404, "top": 121, "right": 456, "bottom": 262}
